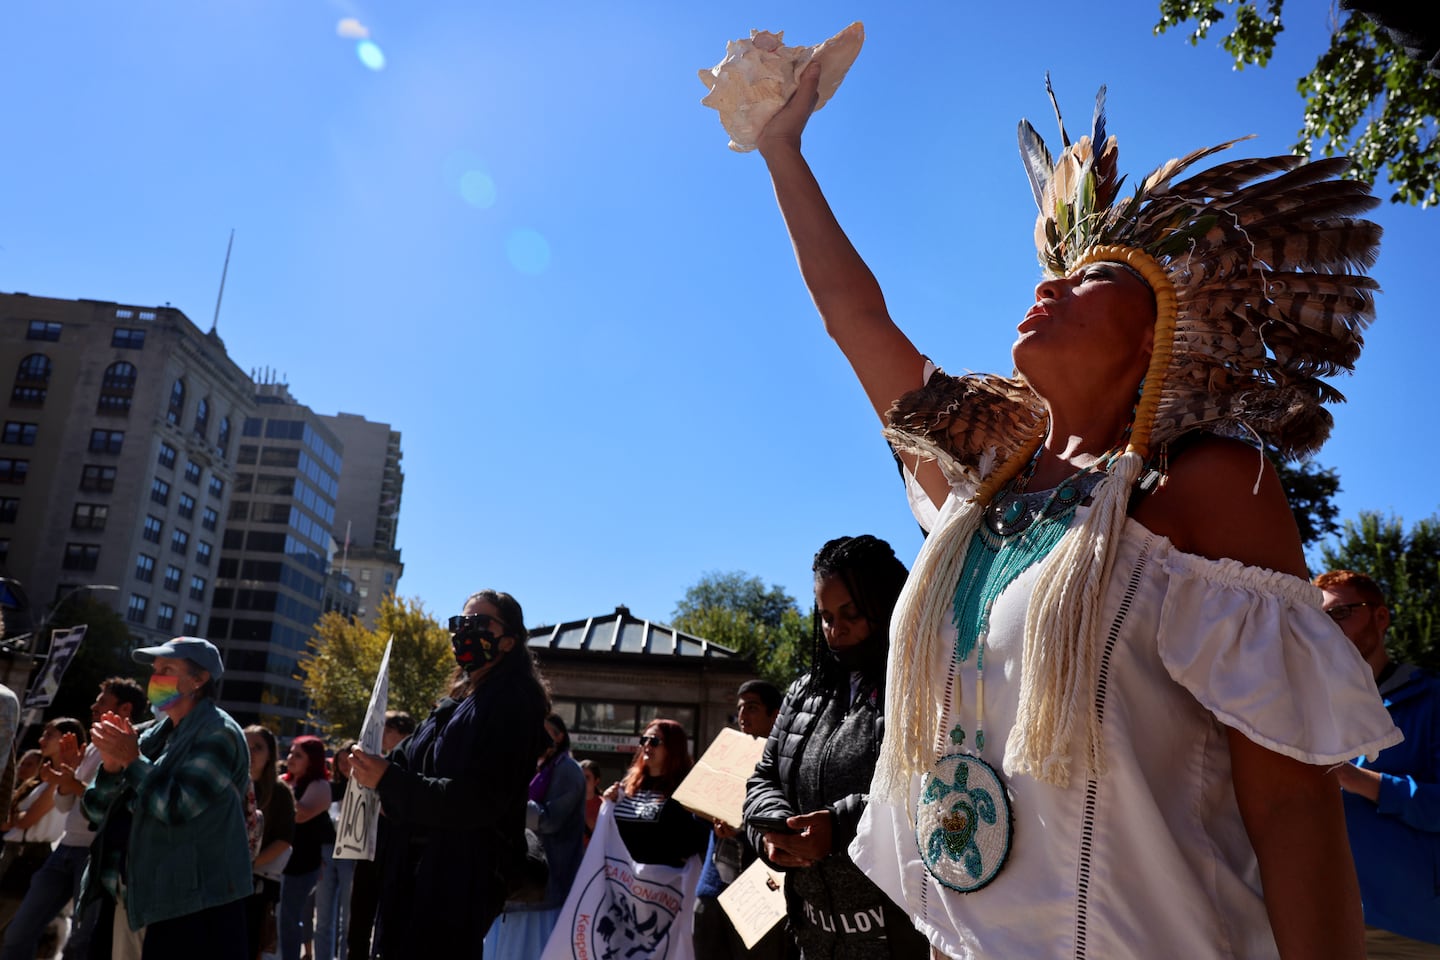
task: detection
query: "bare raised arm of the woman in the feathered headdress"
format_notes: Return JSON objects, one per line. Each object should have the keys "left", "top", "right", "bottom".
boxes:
{"left": 757, "top": 63, "right": 949, "bottom": 505}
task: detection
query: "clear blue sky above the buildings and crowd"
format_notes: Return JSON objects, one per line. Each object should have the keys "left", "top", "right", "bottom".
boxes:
{"left": 0, "top": 0, "right": 1440, "bottom": 623}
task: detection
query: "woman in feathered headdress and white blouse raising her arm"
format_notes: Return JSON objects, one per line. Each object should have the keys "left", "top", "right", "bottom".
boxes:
{"left": 759, "top": 66, "right": 1397, "bottom": 960}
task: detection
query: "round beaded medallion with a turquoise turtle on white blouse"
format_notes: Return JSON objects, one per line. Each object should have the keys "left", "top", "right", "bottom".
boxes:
{"left": 914, "top": 753, "right": 1011, "bottom": 894}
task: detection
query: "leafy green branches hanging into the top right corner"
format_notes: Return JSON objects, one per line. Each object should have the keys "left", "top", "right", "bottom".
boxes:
{"left": 1155, "top": 0, "right": 1440, "bottom": 206}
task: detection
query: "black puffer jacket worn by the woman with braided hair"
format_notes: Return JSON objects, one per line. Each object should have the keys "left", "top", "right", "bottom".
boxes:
{"left": 744, "top": 671, "right": 930, "bottom": 960}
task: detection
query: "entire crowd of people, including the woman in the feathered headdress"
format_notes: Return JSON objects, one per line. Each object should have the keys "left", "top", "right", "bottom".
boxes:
{"left": 0, "top": 13, "right": 1440, "bottom": 960}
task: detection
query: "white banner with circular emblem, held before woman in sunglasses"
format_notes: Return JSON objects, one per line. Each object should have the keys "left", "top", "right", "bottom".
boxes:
{"left": 540, "top": 803, "right": 700, "bottom": 960}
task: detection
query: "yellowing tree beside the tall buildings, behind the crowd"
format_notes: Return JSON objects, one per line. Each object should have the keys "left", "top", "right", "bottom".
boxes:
{"left": 300, "top": 594, "right": 455, "bottom": 740}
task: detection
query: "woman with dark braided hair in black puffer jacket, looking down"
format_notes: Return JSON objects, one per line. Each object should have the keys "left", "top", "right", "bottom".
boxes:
{"left": 744, "top": 535, "right": 926, "bottom": 960}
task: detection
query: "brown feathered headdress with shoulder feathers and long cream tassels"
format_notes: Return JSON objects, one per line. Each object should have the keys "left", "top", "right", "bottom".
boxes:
{"left": 877, "top": 76, "right": 1381, "bottom": 796}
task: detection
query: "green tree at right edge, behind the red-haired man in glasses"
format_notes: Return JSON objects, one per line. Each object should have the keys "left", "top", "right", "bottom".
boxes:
{"left": 1320, "top": 511, "right": 1440, "bottom": 669}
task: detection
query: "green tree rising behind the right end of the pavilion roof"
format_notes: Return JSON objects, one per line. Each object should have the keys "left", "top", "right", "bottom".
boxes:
{"left": 671, "top": 570, "right": 811, "bottom": 689}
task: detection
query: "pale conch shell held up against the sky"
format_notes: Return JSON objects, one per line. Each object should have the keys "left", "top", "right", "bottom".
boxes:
{"left": 700, "top": 20, "right": 865, "bottom": 153}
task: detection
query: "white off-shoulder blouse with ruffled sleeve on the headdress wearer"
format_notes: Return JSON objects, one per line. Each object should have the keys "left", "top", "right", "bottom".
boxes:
{"left": 850, "top": 488, "right": 1401, "bottom": 960}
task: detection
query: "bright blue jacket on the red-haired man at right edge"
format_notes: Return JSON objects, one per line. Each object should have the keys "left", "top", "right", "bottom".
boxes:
{"left": 1345, "top": 664, "right": 1440, "bottom": 943}
